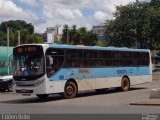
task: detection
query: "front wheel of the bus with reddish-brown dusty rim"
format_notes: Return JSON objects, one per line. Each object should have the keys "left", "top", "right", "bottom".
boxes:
{"left": 63, "top": 81, "right": 78, "bottom": 99}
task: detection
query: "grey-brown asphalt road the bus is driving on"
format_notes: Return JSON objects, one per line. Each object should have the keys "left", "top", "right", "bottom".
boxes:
{"left": 0, "top": 80, "right": 160, "bottom": 114}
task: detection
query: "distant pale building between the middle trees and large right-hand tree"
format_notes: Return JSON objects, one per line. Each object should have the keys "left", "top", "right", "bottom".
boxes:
{"left": 92, "top": 23, "right": 106, "bottom": 40}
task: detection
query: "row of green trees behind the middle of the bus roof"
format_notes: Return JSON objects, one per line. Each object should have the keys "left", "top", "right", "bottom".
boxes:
{"left": 61, "top": 25, "right": 97, "bottom": 46}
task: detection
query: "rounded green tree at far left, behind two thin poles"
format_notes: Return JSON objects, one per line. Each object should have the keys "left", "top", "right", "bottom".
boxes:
{"left": 0, "top": 20, "right": 43, "bottom": 46}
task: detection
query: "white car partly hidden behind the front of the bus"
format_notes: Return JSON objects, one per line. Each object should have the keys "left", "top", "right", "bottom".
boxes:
{"left": 0, "top": 75, "right": 13, "bottom": 92}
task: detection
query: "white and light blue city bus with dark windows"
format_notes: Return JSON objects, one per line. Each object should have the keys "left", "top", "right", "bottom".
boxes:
{"left": 13, "top": 44, "right": 152, "bottom": 98}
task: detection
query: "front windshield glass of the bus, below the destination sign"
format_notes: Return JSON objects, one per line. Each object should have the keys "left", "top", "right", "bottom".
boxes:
{"left": 14, "top": 55, "right": 44, "bottom": 76}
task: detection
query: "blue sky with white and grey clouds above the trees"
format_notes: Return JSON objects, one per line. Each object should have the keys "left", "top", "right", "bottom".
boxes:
{"left": 0, "top": 0, "right": 149, "bottom": 33}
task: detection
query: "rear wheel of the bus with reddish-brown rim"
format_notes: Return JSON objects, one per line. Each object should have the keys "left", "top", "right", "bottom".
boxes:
{"left": 121, "top": 77, "right": 130, "bottom": 92}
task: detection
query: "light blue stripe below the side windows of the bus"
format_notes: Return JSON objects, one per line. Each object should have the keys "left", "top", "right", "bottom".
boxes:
{"left": 49, "top": 67, "right": 149, "bottom": 81}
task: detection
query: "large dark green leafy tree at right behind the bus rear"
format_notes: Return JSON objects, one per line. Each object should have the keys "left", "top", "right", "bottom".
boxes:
{"left": 106, "top": 0, "right": 160, "bottom": 49}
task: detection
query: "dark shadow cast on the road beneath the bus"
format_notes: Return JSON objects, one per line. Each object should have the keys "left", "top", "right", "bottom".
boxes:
{"left": 0, "top": 87, "right": 146, "bottom": 104}
